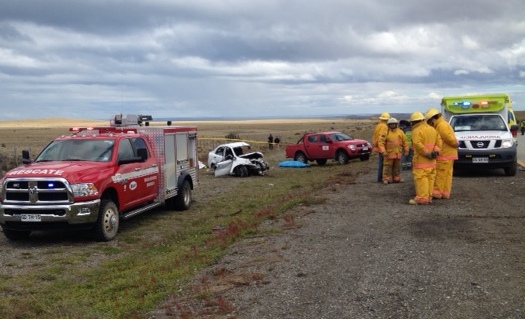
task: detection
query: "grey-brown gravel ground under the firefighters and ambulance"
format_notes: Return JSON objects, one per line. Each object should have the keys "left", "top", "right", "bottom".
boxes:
{"left": 149, "top": 158, "right": 525, "bottom": 319}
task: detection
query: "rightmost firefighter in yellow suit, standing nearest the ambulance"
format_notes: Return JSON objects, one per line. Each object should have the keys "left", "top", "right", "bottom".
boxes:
{"left": 425, "top": 108, "right": 458, "bottom": 199}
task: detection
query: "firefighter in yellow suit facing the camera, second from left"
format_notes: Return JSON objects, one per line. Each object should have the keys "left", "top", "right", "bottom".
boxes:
{"left": 379, "top": 117, "right": 408, "bottom": 185}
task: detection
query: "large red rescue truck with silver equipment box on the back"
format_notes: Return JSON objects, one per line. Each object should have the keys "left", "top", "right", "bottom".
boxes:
{"left": 0, "top": 114, "right": 199, "bottom": 241}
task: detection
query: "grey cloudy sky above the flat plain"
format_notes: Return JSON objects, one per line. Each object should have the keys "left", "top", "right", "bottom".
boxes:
{"left": 0, "top": 0, "right": 525, "bottom": 120}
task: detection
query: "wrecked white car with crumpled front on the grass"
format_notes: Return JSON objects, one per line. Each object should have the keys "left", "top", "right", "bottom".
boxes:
{"left": 208, "top": 142, "right": 270, "bottom": 177}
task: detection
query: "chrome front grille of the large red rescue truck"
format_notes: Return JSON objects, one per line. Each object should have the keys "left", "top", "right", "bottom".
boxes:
{"left": 4, "top": 179, "right": 71, "bottom": 205}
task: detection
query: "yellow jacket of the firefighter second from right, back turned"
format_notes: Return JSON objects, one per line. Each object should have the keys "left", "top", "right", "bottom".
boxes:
{"left": 412, "top": 121, "right": 443, "bottom": 169}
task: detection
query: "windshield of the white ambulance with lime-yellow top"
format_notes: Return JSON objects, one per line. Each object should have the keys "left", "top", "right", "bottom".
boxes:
{"left": 450, "top": 114, "right": 508, "bottom": 132}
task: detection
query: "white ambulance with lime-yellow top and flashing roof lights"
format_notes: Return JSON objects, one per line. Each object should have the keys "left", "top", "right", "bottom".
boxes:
{"left": 441, "top": 93, "right": 518, "bottom": 176}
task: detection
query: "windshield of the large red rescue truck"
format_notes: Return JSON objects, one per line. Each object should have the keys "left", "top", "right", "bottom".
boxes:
{"left": 35, "top": 139, "right": 114, "bottom": 162}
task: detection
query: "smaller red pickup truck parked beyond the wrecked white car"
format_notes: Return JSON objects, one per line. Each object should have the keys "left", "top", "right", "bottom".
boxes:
{"left": 285, "top": 131, "right": 372, "bottom": 165}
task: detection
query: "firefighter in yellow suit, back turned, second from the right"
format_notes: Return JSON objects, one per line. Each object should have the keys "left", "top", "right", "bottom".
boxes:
{"left": 408, "top": 112, "right": 442, "bottom": 205}
